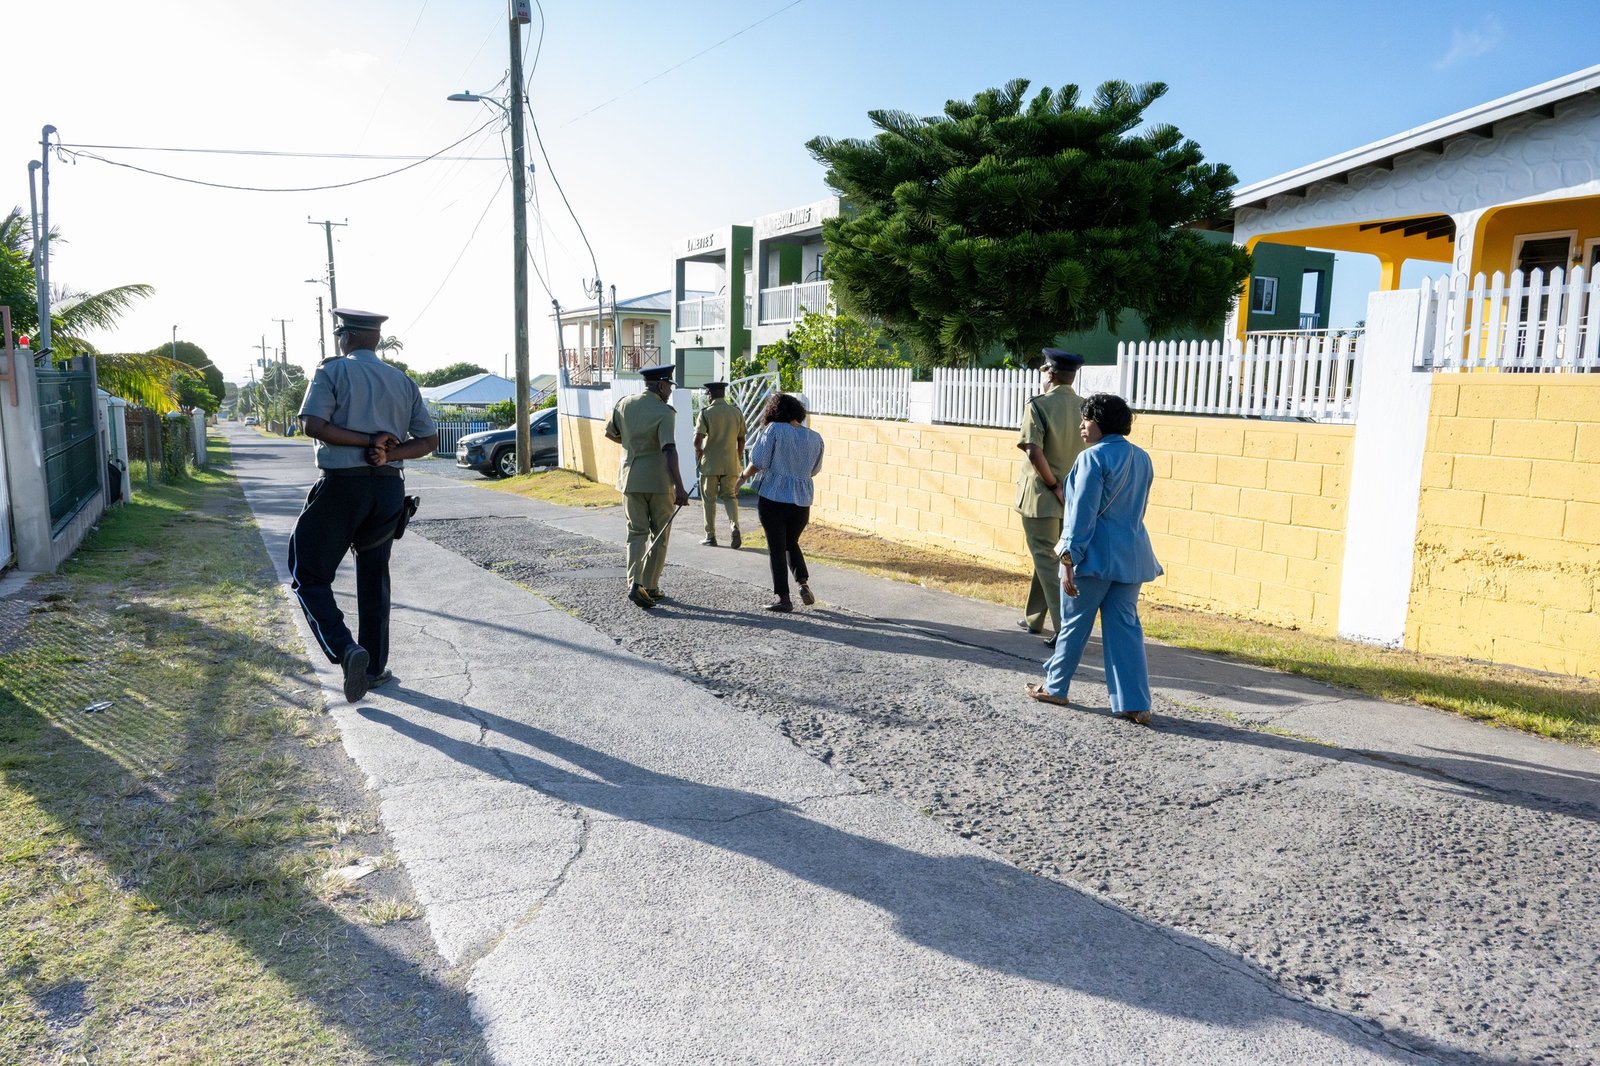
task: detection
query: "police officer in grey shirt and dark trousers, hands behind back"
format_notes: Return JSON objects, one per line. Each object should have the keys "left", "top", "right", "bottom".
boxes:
{"left": 290, "top": 307, "right": 438, "bottom": 703}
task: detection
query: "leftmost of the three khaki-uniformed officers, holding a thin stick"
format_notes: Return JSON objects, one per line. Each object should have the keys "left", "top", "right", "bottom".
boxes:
{"left": 605, "top": 365, "right": 690, "bottom": 607}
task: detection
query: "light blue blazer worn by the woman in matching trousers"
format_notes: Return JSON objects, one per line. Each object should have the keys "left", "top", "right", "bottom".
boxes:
{"left": 1056, "top": 435, "right": 1162, "bottom": 583}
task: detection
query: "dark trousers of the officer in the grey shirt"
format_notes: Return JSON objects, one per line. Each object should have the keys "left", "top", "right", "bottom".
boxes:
{"left": 290, "top": 467, "right": 405, "bottom": 675}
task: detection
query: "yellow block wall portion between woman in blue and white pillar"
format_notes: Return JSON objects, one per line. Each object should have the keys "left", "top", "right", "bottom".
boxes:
{"left": 1130, "top": 415, "right": 1354, "bottom": 632}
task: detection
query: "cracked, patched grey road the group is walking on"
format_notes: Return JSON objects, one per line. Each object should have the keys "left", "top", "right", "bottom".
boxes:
{"left": 235, "top": 425, "right": 1600, "bottom": 1063}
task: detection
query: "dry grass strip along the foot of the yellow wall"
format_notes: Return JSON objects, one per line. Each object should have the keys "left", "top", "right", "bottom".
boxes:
{"left": 744, "top": 522, "right": 1600, "bottom": 746}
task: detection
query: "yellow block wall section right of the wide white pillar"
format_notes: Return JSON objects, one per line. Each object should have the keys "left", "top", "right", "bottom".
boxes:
{"left": 1406, "top": 375, "right": 1600, "bottom": 677}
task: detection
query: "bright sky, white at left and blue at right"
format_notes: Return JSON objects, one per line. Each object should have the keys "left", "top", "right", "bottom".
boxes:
{"left": 0, "top": 0, "right": 1600, "bottom": 381}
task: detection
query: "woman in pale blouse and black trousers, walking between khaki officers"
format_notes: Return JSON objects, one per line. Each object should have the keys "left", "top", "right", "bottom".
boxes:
{"left": 739, "top": 392, "right": 822, "bottom": 613}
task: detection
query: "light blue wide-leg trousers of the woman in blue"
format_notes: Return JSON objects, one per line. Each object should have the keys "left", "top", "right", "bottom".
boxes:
{"left": 1045, "top": 575, "right": 1150, "bottom": 714}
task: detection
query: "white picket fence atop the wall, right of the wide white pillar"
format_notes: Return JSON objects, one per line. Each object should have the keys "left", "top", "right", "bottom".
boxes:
{"left": 1413, "top": 267, "right": 1600, "bottom": 373}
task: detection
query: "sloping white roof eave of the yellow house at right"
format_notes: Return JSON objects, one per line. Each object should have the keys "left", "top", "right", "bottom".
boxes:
{"left": 1194, "top": 66, "right": 1600, "bottom": 230}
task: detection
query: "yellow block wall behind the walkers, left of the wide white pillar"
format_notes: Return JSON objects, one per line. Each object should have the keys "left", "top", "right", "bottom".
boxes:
{"left": 811, "top": 415, "right": 1354, "bottom": 632}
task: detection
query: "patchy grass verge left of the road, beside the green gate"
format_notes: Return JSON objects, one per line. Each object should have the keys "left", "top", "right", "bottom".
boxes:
{"left": 0, "top": 439, "right": 482, "bottom": 1063}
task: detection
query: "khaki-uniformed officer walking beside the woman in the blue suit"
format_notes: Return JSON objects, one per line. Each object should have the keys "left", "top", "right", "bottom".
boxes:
{"left": 1016, "top": 347, "right": 1086, "bottom": 647}
